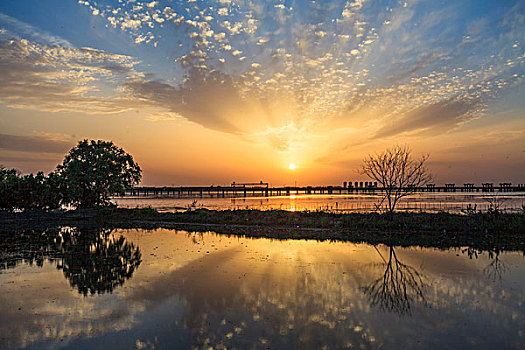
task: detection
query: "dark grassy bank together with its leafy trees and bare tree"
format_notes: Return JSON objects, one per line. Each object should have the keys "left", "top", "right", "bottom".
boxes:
{"left": 0, "top": 140, "right": 525, "bottom": 251}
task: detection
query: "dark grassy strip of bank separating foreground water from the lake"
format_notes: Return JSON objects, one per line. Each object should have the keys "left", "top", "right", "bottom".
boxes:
{"left": 0, "top": 207, "right": 525, "bottom": 251}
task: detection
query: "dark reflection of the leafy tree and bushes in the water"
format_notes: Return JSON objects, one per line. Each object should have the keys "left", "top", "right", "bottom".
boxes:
{"left": 0, "top": 229, "right": 141, "bottom": 295}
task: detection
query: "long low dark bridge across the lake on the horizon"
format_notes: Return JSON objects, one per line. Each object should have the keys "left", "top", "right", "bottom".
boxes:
{"left": 125, "top": 182, "right": 525, "bottom": 197}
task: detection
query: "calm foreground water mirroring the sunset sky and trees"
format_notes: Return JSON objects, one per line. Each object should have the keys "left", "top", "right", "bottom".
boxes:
{"left": 0, "top": 228, "right": 525, "bottom": 349}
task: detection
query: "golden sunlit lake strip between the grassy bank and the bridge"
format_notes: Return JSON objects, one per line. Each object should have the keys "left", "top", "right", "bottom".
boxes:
{"left": 113, "top": 192, "right": 525, "bottom": 213}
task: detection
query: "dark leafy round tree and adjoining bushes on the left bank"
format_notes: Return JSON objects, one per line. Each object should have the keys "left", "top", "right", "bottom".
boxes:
{"left": 0, "top": 140, "right": 142, "bottom": 211}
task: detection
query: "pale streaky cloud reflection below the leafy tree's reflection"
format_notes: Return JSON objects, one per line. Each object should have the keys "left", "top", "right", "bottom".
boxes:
{"left": 0, "top": 280, "right": 140, "bottom": 348}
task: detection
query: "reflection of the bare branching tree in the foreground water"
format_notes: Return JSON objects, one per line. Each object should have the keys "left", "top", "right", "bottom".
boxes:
{"left": 364, "top": 247, "right": 426, "bottom": 315}
